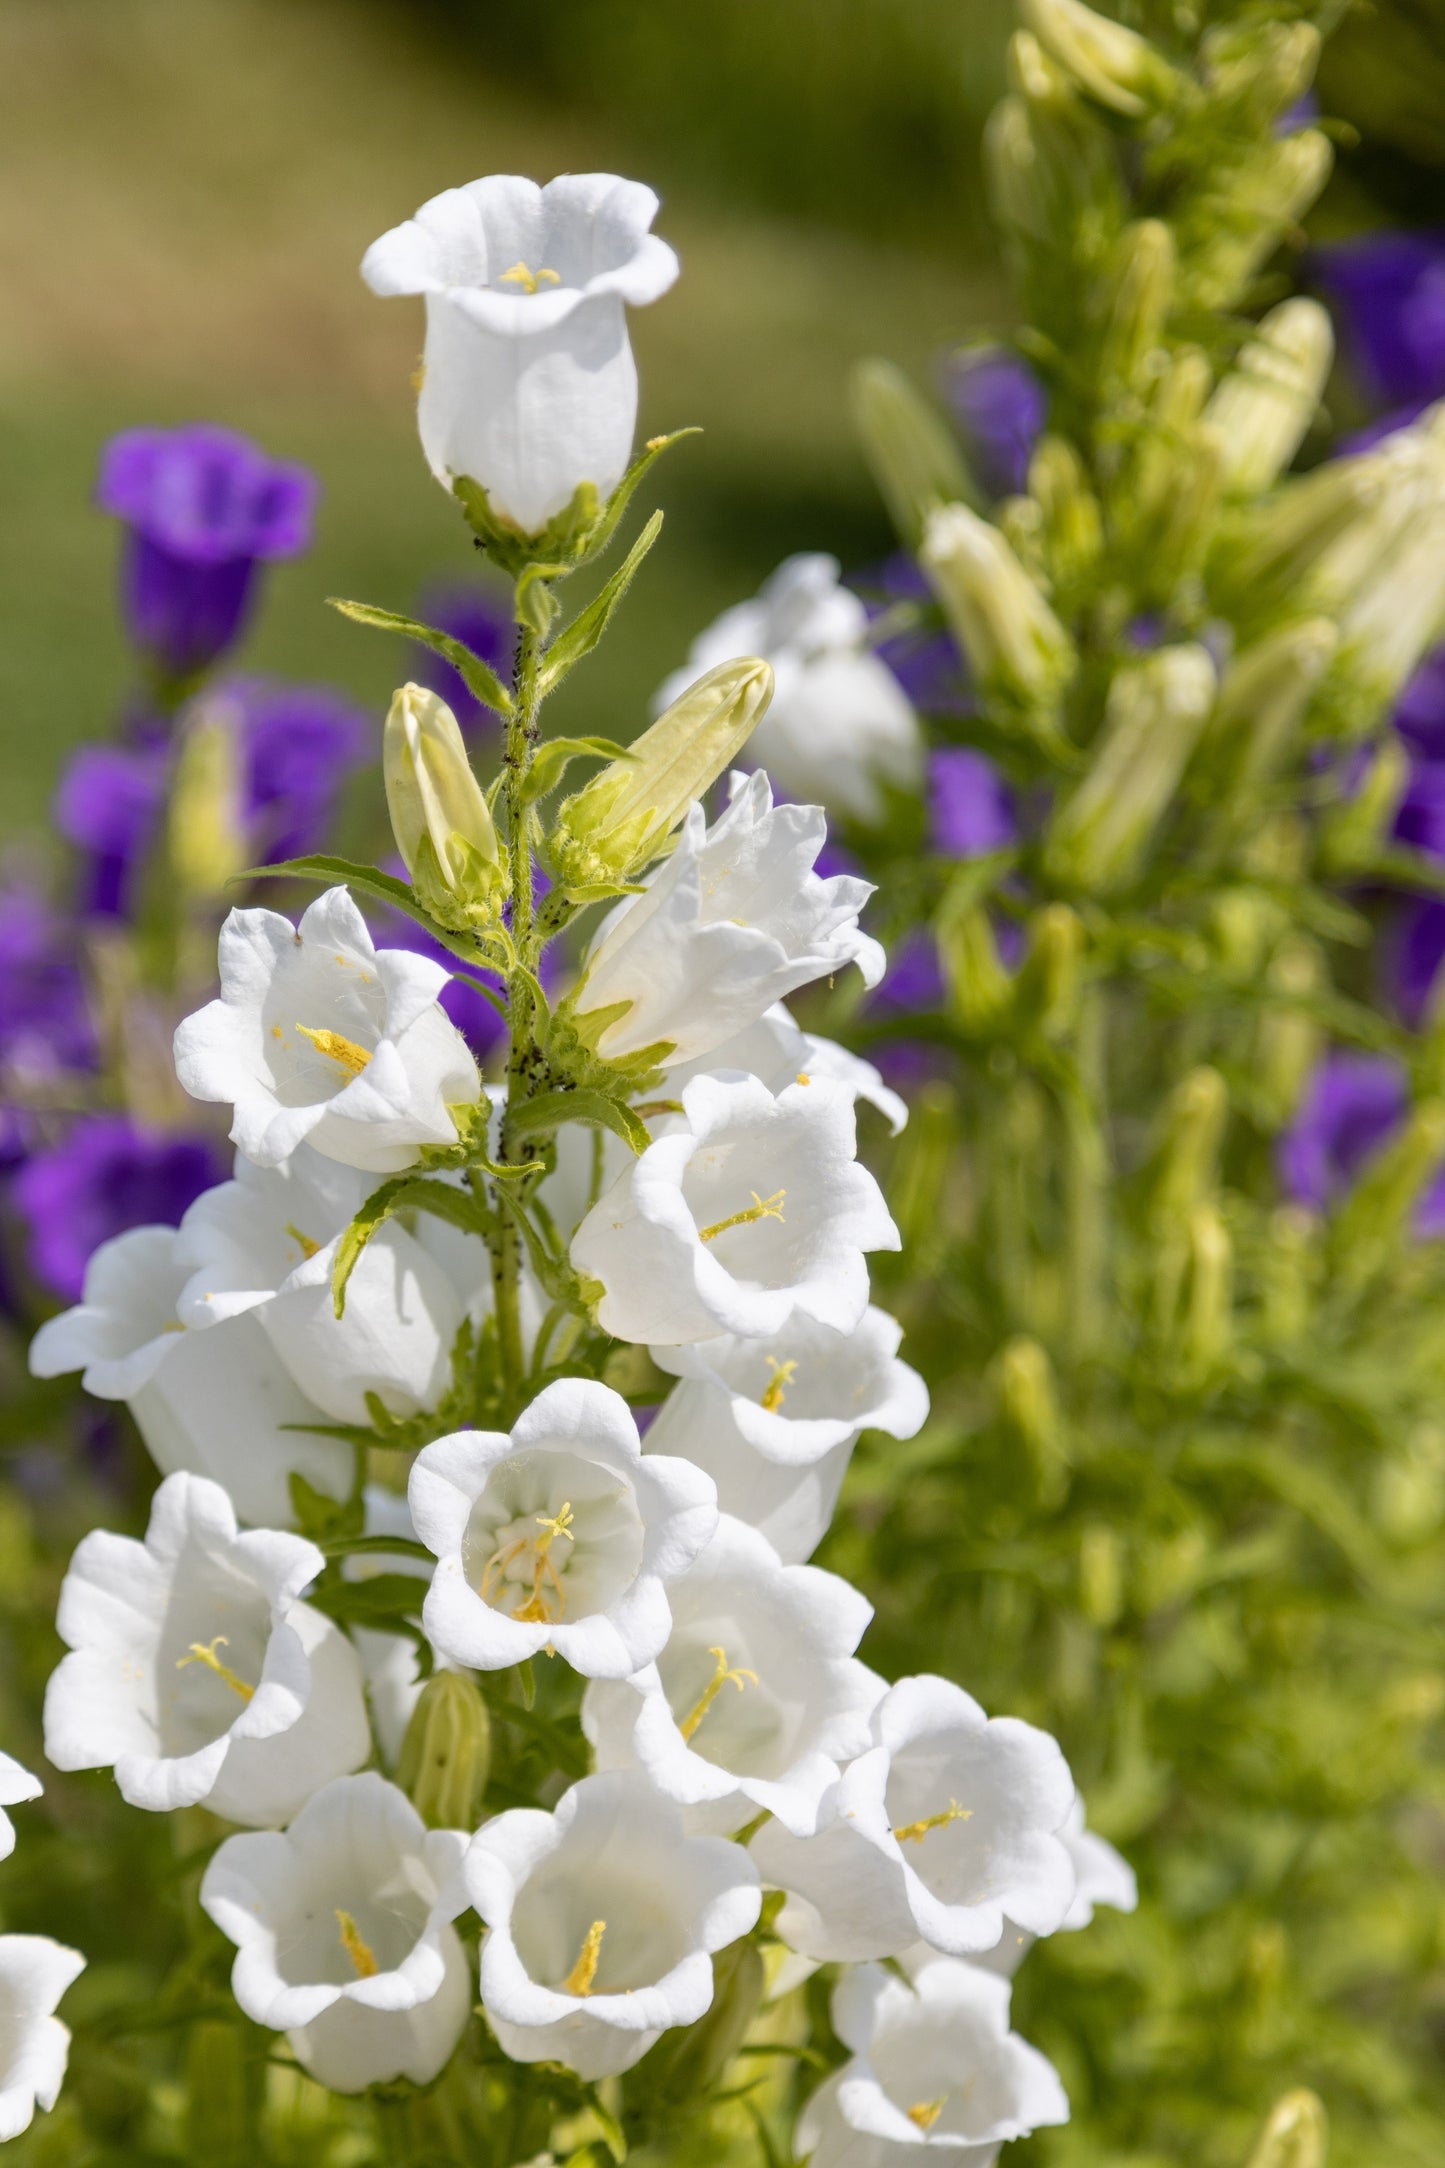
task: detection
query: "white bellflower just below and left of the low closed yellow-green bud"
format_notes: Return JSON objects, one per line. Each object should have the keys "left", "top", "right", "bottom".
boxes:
{"left": 201, "top": 1769, "right": 472, "bottom": 2092}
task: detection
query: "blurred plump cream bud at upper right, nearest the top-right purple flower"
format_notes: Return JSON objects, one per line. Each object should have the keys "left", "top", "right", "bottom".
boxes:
{"left": 1207, "top": 299, "right": 1335, "bottom": 496}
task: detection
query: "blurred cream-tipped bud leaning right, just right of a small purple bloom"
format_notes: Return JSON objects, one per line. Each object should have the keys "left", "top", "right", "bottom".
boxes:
{"left": 1046, "top": 646, "right": 1215, "bottom": 891}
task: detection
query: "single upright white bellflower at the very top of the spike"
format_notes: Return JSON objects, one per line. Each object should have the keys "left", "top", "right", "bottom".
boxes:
{"left": 362, "top": 173, "right": 678, "bottom": 533}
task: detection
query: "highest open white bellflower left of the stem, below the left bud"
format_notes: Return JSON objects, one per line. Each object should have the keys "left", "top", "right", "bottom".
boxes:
{"left": 175, "top": 889, "right": 481, "bottom": 1175}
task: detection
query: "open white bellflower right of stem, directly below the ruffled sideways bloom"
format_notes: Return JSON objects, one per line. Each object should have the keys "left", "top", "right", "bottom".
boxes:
{"left": 572, "top": 1073, "right": 899, "bottom": 1346}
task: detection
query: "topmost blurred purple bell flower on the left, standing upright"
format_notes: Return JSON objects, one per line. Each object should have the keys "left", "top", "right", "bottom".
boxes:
{"left": 95, "top": 423, "right": 316, "bottom": 679}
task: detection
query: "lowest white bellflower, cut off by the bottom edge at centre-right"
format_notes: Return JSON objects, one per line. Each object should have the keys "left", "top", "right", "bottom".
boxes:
{"left": 797, "top": 1958, "right": 1068, "bottom": 2168}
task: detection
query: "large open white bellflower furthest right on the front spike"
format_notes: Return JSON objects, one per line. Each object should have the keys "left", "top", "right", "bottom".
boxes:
{"left": 752, "top": 1676, "right": 1075, "bottom": 1962}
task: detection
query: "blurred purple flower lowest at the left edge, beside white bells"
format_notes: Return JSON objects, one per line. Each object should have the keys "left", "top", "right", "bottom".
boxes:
{"left": 13, "top": 1114, "right": 225, "bottom": 1303}
